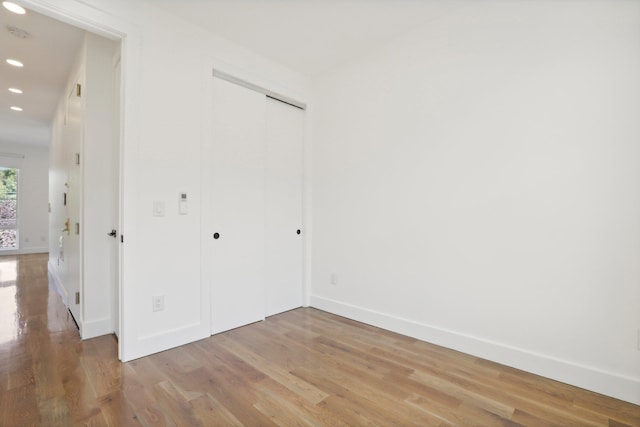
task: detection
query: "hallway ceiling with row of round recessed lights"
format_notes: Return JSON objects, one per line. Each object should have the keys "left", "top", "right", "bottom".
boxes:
{"left": 0, "top": 2, "right": 84, "bottom": 147}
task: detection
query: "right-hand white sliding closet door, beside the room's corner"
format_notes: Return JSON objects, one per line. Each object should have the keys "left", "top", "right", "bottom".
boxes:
{"left": 265, "top": 98, "right": 304, "bottom": 316}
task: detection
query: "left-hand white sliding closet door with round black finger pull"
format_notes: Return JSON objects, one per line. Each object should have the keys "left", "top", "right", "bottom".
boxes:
{"left": 204, "top": 78, "right": 266, "bottom": 334}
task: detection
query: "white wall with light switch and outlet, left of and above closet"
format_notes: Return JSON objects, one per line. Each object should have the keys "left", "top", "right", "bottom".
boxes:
{"left": 124, "top": 1, "right": 307, "bottom": 359}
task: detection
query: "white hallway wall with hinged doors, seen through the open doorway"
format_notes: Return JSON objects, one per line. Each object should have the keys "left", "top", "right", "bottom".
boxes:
{"left": 49, "top": 33, "right": 118, "bottom": 339}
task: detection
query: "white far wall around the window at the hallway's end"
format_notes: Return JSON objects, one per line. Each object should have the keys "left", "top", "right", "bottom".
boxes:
{"left": 0, "top": 141, "right": 49, "bottom": 255}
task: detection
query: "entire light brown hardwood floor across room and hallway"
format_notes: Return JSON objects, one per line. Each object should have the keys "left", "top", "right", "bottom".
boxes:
{"left": 0, "top": 255, "right": 640, "bottom": 427}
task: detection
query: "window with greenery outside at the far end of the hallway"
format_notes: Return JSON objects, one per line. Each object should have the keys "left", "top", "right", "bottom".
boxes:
{"left": 0, "top": 167, "right": 18, "bottom": 251}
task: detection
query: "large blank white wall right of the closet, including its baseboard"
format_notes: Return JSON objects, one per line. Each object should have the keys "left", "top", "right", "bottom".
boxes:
{"left": 312, "top": 1, "right": 640, "bottom": 403}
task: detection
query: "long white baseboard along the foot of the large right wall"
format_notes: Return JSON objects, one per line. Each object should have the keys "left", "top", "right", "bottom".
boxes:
{"left": 311, "top": 295, "right": 640, "bottom": 405}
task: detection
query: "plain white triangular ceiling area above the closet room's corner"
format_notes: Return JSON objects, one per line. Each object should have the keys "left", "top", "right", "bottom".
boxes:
{"left": 149, "top": 0, "right": 463, "bottom": 77}
